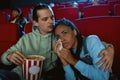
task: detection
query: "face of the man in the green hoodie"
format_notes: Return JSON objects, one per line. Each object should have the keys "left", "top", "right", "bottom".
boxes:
{"left": 35, "top": 9, "right": 54, "bottom": 35}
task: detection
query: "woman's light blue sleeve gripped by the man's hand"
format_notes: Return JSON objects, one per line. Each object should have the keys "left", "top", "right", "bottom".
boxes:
{"left": 74, "top": 35, "right": 109, "bottom": 80}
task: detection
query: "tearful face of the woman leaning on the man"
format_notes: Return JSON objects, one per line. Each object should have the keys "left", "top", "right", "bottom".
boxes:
{"left": 55, "top": 25, "right": 77, "bottom": 49}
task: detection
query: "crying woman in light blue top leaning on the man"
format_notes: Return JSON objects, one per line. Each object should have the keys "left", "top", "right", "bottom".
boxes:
{"left": 54, "top": 19, "right": 109, "bottom": 80}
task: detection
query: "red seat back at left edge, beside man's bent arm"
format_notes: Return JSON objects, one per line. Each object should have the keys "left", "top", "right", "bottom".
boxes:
{"left": 0, "top": 23, "right": 21, "bottom": 56}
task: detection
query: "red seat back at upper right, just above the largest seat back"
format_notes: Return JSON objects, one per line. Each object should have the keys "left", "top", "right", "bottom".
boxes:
{"left": 83, "top": 4, "right": 109, "bottom": 17}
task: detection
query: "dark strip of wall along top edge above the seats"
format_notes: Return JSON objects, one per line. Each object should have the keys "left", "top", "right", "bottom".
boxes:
{"left": 0, "top": 0, "right": 78, "bottom": 9}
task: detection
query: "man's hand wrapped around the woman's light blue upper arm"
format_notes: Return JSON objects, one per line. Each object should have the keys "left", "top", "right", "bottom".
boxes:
{"left": 97, "top": 47, "right": 114, "bottom": 71}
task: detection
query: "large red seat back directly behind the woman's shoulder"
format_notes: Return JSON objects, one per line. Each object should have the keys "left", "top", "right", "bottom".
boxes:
{"left": 75, "top": 16, "right": 120, "bottom": 46}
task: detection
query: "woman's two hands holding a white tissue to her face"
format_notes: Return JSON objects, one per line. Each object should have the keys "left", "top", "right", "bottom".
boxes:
{"left": 54, "top": 40, "right": 77, "bottom": 66}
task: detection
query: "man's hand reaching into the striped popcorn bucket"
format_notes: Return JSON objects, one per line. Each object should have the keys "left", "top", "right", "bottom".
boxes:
{"left": 7, "top": 51, "right": 26, "bottom": 65}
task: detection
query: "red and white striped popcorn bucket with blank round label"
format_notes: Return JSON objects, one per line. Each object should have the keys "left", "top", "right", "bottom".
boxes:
{"left": 22, "top": 55, "right": 45, "bottom": 80}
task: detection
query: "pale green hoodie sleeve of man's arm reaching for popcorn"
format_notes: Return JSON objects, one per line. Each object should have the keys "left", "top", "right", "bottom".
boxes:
{"left": 1, "top": 37, "right": 23, "bottom": 65}
